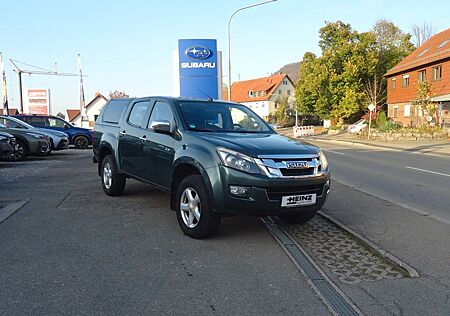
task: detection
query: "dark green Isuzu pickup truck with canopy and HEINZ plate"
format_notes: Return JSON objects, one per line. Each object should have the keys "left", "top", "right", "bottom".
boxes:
{"left": 93, "top": 97, "right": 330, "bottom": 238}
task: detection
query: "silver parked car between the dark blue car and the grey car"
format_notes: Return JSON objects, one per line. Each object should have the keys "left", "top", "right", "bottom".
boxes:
{"left": 0, "top": 115, "right": 69, "bottom": 150}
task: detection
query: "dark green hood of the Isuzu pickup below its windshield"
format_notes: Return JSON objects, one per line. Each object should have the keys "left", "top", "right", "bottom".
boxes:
{"left": 195, "top": 132, "right": 319, "bottom": 157}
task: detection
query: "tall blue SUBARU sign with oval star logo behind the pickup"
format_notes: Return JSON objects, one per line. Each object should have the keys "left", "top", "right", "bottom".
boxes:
{"left": 178, "top": 39, "right": 219, "bottom": 99}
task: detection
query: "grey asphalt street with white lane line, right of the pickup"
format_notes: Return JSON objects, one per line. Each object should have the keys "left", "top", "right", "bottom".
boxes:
{"left": 313, "top": 140, "right": 450, "bottom": 223}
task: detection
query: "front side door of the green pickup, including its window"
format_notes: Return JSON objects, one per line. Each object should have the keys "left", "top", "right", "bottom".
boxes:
{"left": 144, "top": 100, "right": 176, "bottom": 188}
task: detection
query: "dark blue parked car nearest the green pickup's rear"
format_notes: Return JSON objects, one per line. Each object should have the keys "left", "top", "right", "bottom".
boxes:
{"left": 15, "top": 114, "right": 92, "bottom": 149}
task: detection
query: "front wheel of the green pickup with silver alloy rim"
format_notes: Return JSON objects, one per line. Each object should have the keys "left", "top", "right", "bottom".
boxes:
{"left": 174, "top": 175, "right": 221, "bottom": 239}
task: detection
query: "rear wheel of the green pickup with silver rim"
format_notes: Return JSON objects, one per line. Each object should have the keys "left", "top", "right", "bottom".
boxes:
{"left": 100, "top": 155, "right": 126, "bottom": 196}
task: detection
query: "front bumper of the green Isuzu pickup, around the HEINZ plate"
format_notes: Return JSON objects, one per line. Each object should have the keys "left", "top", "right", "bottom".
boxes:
{"left": 207, "top": 166, "right": 330, "bottom": 216}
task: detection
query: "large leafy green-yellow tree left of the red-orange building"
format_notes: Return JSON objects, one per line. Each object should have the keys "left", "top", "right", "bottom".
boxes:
{"left": 296, "top": 20, "right": 414, "bottom": 122}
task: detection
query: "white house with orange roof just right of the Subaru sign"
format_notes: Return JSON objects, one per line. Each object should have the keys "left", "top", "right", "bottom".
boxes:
{"left": 231, "top": 74, "right": 295, "bottom": 120}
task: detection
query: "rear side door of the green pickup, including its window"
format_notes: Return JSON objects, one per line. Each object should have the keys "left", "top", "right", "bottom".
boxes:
{"left": 118, "top": 100, "right": 151, "bottom": 179}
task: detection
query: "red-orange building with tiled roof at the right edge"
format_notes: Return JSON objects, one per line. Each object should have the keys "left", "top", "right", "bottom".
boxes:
{"left": 385, "top": 28, "right": 450, "bottom": 127}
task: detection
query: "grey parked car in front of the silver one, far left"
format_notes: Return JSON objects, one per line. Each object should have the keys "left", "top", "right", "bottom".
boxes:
{"left": 0, "top": 123, "right": 51, "bottom": 161}
